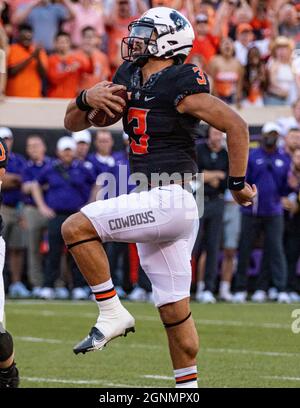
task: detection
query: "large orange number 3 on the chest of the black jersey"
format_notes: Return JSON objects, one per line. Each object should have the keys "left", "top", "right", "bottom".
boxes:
{"left": 128, "top": 108, "right": 150, "bottom": 154}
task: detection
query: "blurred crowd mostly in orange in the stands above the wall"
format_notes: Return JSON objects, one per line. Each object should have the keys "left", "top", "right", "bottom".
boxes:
{"left": 0, "top": 0, "right": 300, "bottom": 106}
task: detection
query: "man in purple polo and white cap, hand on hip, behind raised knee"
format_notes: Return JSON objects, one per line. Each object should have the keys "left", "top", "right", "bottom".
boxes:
{"left": 31, "top": 136, "right": 95, "bottom": 300}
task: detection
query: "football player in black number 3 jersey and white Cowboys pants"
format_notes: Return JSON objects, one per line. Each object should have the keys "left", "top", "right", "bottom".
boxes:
{"left": 62, "top": 7, "right": 256, "bottom": 388}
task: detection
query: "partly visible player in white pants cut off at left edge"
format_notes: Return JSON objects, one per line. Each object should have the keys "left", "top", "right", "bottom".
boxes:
{"left": 0, "top": 138, "right": 19, "bottom": 388}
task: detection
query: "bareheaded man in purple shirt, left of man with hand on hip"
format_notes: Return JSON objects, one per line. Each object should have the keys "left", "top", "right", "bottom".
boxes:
{"left": 22, "top": 135, "right": 51, "bottom": 297}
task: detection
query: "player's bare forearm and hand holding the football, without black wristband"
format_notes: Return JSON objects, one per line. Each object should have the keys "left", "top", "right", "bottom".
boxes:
{"left": 64, "top": 81, "right": 126, "bottom": 132}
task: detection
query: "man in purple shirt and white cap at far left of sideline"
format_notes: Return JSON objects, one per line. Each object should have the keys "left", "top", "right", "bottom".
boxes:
{"left": 0, "top": 127, "right": 30, "bottom": 297}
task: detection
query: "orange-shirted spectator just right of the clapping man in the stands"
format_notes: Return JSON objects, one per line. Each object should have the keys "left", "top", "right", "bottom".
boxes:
{"left": 48, "top": 31, "right": 93, "bottom": 98}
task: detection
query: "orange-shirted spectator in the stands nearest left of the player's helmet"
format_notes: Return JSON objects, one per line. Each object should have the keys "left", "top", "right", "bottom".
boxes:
{"left": 76, "top": 26, "right": 110, "bottom": 90}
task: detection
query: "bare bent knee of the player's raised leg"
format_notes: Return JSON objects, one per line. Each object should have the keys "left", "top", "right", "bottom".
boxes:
{"left": 61, "top": 212, "right": 97, "bottom": 243}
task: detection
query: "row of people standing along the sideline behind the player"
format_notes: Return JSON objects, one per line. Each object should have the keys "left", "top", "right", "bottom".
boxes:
{"left": 0, "top": 99, "right": 300, "bottom": 303}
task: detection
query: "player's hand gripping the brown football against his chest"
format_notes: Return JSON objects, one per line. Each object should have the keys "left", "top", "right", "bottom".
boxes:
{"left": 86, "top": 81, "right": 126, "bottom": 118}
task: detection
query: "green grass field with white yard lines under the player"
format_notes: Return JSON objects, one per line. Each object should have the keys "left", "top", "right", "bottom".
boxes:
{"left": 6, "top": 301, "right": 300, "bottom": 388}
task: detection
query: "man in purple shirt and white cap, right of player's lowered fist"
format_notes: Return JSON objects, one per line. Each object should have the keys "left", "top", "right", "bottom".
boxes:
{"left": 233, "top": 122, "right": 289, "bottom": 303}
